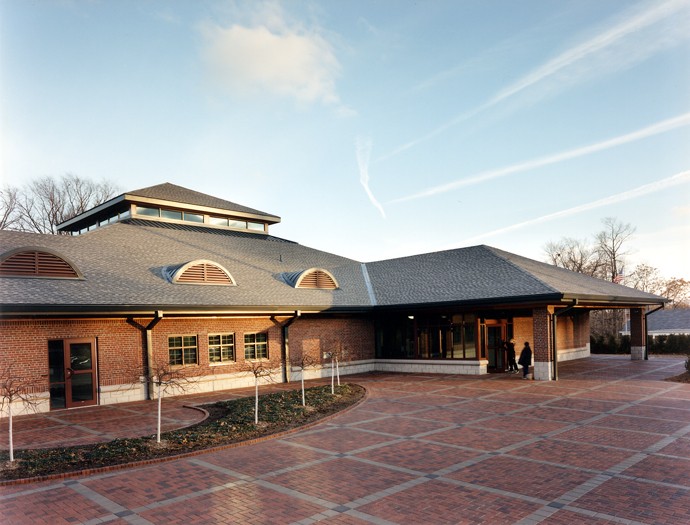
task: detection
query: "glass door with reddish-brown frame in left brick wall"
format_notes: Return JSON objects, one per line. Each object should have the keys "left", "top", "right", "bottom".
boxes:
{"left": 48, "top": 339, "right": 96, "bottom": 409}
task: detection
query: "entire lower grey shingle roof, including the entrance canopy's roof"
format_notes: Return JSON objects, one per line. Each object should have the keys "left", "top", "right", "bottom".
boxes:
{"left": 0, "top": 219, "right": 663, "bottom": 310}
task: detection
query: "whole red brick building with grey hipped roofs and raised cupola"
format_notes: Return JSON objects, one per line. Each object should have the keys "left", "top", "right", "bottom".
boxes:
{"left": 0, "top": 184, "right": 664, "bottom": 410}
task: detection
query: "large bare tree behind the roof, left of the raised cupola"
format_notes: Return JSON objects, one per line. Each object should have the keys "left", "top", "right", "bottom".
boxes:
{"left": 5, "top": 173, "right": 117, "bottom": 234}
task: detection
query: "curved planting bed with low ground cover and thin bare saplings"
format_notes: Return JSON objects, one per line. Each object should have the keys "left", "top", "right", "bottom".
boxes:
{"left": 0, "top": 384, "right": 365, "bottom": 483}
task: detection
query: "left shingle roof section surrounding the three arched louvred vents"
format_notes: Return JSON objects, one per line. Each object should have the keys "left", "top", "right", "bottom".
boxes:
{"left": 0, "top": 221, "right": 369, "bottom": 308}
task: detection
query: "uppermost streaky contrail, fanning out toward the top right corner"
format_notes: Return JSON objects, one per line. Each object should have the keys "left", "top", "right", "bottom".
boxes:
{"left": 376, "top": 0, "right": 690, "bottom": 162}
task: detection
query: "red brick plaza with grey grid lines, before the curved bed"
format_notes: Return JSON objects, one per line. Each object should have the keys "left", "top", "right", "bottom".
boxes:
{"left": 0, "top": 356, "right": 690, "bottom": 525}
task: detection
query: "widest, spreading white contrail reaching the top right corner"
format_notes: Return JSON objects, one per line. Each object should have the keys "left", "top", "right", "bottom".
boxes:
{"left": 376, "top": 0, "right": 690, "bottom": 161}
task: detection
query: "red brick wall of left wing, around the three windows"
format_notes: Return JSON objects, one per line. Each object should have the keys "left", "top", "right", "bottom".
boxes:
{"left": 0, "top": 317, "right": 374, "bottom": 404}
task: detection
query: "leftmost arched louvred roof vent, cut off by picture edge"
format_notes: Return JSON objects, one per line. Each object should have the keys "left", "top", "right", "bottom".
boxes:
{"left": 0, "top": 248, "right": 82, "bottom": 279}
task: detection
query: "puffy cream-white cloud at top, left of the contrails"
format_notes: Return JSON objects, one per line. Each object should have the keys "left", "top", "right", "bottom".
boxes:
{"left": 201, "top": 4, "right": 342, "bottom": 111}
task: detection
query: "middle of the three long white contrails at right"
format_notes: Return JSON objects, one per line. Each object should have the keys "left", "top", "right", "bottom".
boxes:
{"left": 389, "top": 112, "right": 690, "bottom": 204}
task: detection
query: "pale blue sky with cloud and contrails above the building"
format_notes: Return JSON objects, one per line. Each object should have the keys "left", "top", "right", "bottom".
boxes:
{"left": 0, "top": 0, "right": 690, "bottom": 279}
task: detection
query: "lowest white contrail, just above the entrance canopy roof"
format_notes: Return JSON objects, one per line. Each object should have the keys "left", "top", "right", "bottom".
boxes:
{"left": 456, "top": 170, "right": 690, "bottom": 244}
